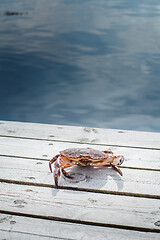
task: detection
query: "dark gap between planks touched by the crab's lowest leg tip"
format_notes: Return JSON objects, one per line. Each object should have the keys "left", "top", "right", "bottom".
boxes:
{"left": 0, "top": 179, "right": 160, "bottom": 199}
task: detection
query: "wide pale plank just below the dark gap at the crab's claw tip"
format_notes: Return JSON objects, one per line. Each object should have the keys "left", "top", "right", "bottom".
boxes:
{"left": 0, "top": 183, "right": 160, "bottom": 232}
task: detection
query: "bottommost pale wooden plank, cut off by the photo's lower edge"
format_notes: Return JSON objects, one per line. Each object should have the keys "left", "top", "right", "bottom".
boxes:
{"left": 0, "top": 214, "right": 159, "bottom": 240}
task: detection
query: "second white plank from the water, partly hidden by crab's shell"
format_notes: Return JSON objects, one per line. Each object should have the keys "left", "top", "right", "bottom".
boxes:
{"left": 0, "top": 137, "right": 160, "bottom": 169}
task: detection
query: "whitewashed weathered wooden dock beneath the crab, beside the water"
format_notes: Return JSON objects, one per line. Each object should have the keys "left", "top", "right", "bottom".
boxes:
{"left": 0, "top": 121, "right": 160, "bottom": 240}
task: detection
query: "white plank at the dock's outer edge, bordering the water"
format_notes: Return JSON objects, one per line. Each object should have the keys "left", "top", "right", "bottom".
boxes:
{"left": 0, "top": 121, "right": 160, "bottom": 149}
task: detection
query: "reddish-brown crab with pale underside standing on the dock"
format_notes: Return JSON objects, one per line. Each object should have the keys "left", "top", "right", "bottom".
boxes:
{"left": 49, "top": 148, "right": 124, "bottom": 188}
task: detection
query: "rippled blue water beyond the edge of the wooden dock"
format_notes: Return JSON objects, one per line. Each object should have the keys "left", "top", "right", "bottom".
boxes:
{"left": 0, "top": 0, "right": 160, "bottom": 132}
